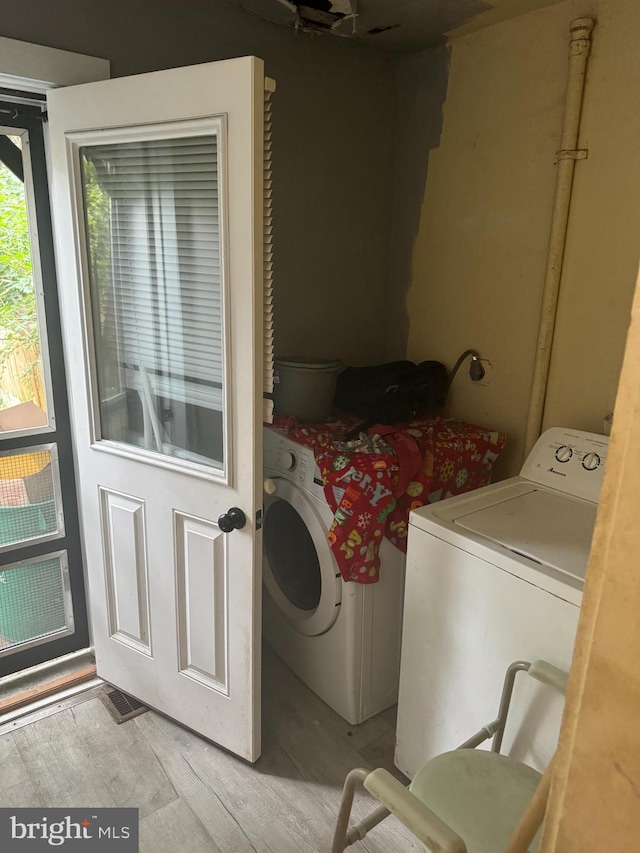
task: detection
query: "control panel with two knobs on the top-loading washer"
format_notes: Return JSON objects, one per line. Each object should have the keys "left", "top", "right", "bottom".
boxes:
{"left": 520, "top": 427, "right": 609, "bottom": 503}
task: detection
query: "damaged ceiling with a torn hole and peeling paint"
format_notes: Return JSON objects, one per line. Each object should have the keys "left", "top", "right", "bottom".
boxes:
{"left": 231, "top": 0, "right": 560, "bottom": 51}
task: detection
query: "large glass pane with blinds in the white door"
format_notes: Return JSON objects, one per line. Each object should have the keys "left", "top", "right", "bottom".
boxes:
{"left": 80, "top": 134, "right": 224, "bottom": 468}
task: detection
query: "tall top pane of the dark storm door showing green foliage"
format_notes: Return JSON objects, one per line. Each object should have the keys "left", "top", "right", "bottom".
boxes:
{"left": 0, "top": 129, "right": 48, "bottom": 436}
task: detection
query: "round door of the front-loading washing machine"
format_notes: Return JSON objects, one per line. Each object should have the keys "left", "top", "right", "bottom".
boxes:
{"left": 263, "top": 477, "right": 342, "bottom": 636}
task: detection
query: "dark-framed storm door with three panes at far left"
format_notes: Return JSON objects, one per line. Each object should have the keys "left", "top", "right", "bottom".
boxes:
{"left": 0, "top": 103, "right": 89, "bottom": 676}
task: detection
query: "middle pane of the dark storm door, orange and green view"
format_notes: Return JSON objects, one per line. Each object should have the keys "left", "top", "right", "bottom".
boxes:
{"left": 0, "top": 445, "right": 64, "bottom": 550}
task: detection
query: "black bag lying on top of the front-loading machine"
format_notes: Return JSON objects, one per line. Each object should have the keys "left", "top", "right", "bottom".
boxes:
{"left": 334, "top": 361, "right": 449, "bottom": 426}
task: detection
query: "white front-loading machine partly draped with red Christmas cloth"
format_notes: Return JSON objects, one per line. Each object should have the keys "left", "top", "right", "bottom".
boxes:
{"left": 263, "top": 428, "right": 405, "bottom": 725}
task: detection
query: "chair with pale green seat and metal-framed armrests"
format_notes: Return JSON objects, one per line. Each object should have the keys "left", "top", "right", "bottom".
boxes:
{"left": 332, "top": 661, "right": 567, "bottom": 853}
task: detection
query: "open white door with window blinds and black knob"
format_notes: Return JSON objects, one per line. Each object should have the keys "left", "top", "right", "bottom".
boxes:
{"left": 49, "top": 57, "right": 265, "bottom": 761}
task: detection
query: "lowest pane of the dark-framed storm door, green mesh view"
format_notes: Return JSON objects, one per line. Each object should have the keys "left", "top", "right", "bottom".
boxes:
{"left": 0, "top": 552, "right": 73, "bottom": 655}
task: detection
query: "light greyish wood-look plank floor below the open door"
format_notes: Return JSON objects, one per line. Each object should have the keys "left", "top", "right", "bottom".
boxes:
{"left": 0, "top": 647, "right": 418, "bottom": 853}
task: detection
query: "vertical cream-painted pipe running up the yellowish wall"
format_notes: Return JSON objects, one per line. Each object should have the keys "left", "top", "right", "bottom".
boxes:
{"left": 524, "top": 18, "right": 594, "bottom": 457}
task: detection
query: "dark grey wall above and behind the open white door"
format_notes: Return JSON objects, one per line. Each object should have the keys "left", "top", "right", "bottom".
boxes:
{"left": 0, "top": 0, "right": 396, "bottom": 363}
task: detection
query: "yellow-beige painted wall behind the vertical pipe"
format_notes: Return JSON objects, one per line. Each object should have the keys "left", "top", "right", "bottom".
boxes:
{"left": 407, "top": 0, "right": 640, "bottom": 476}
